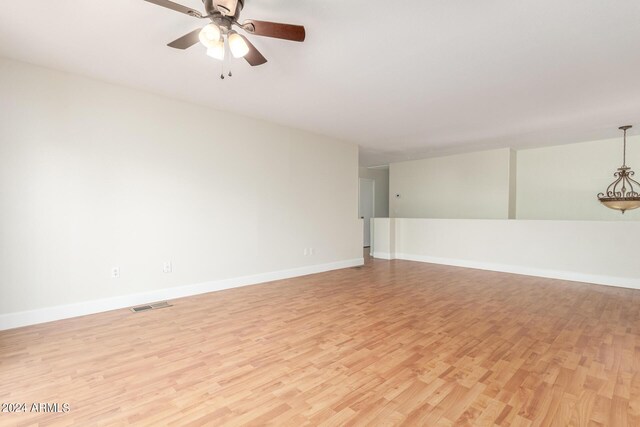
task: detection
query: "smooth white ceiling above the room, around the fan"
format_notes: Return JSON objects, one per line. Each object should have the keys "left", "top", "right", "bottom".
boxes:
{"left": 0, "top": 0, "right": 640, "bottom": 165}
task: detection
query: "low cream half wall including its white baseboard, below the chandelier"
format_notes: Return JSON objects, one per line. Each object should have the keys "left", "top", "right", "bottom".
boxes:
{"left": 373, "top": 218, "right": 640, "bottom": 289}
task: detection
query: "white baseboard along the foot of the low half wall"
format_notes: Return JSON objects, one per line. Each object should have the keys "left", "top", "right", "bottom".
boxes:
{"left": 395, "top": 253, "right": 640, "bottom": 289}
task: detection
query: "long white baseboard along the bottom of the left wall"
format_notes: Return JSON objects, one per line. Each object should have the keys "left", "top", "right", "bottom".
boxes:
{"left": 0, "top": 258, "right": 364, "bottom": 331}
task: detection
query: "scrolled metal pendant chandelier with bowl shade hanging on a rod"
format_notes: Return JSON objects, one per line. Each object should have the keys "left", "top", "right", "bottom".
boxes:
{"left": 598, "top": 126, "right": 640, "bottom": 213}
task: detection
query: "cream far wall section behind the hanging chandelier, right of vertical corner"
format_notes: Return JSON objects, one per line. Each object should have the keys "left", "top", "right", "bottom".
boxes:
{"left": 517, "top": 136, "right": 640, "bottom": 221}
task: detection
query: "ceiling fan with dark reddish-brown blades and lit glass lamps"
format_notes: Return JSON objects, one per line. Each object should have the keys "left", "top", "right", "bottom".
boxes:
{"left": 145, "top": 0, "right": 306, "bottom": 66}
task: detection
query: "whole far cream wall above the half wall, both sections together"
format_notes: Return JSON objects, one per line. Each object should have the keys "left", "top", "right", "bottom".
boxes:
{"left": 389, "top": 136, "right": 640, "bottom": 221}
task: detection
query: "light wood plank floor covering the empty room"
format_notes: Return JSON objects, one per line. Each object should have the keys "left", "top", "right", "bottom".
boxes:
{"left": 0, "top": 260, "right": 640, "bottom": 426}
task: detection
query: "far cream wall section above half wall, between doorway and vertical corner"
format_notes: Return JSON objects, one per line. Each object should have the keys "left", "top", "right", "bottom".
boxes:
{"left": 389, "top": 148, "right": 514, "bottom": 219}
